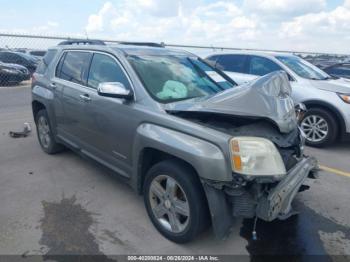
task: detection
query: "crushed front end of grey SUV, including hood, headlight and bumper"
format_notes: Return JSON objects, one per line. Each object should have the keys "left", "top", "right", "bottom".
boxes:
{"left": 166, "top": 72, "right": 317, "bottom": 238}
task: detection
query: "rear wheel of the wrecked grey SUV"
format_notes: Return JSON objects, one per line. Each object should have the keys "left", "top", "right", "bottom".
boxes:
{"left": 35, "top": 109, "right": 64, "bottom": 154}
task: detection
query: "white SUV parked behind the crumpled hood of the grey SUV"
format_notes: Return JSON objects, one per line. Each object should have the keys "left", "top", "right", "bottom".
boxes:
{"left": 207, "top": 52, "right": 350, "bottom": 147}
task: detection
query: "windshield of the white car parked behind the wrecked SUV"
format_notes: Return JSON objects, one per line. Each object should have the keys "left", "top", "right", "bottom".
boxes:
{"left": 276, "top": 56, "right": 330, "bottom": 80}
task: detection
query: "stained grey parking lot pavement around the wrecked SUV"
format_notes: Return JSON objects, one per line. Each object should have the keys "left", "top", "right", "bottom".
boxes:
{"left": 0, "top": 84, "right": 350, "bottom": 261}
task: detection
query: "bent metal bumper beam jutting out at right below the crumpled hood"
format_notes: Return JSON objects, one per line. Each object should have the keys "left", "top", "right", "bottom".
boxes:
{"left": 256, "top": 157, "right": 317, "bottom": 221}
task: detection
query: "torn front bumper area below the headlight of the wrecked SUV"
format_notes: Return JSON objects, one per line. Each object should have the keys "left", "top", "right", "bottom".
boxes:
{"left": 202, "top": 157, "right": 318, "bottom": 238}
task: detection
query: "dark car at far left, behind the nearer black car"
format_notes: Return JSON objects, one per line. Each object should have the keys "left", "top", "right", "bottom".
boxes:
{"left": 0, "top": 51, "right": 39, "bottom": 74}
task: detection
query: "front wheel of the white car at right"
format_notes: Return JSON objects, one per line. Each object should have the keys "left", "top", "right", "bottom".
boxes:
{"left": 301, "top": 108, "right": 339, "bottom": 147}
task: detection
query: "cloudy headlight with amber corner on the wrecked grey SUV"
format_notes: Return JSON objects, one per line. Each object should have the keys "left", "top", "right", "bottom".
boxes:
{"left": 230, "top": 137, "right": 287, "bottom": 176}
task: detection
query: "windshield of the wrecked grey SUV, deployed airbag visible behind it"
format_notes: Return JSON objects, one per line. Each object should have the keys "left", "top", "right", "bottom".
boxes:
{"left": 128, "top": 55, "right": 235, "bottom": 103}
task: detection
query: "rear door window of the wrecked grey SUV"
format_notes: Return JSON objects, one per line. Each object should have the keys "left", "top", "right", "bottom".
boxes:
{"left": 56, "top": 51, "right": 91, "bottom": 85}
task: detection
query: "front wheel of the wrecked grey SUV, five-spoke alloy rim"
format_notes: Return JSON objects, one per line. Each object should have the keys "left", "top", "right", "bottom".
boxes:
{"left": 144, "top": 160, "right": 210, "bottom": 243}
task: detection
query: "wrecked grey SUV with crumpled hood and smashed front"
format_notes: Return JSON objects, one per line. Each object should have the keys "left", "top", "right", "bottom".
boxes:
{"left": 32, "top": 40, "right": 317, "bottom": 243}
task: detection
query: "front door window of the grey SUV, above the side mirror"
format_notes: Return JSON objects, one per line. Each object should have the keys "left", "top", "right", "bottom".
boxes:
{"left": 88, "top": 54, "right": 130, "bottom": 89}
